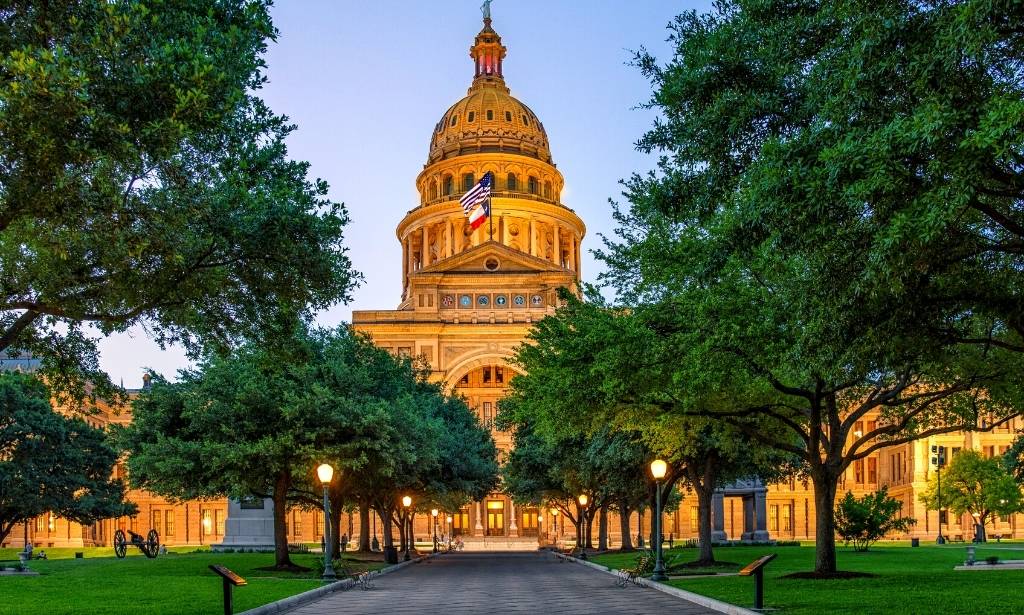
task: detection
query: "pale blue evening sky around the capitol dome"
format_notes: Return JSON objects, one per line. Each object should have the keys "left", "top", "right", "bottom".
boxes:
{"left": 100, "top": 0, "right": 711, "bottom": 388}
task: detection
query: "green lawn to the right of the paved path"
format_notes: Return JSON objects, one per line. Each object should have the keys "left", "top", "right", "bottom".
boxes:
{"left": 591, "top": 542, "right": 1024, "bottom": 615}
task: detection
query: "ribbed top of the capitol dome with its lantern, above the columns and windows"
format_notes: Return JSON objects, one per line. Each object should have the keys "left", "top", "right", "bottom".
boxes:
{"left": 427, "top": 20, "right": 552, "bottom": 165}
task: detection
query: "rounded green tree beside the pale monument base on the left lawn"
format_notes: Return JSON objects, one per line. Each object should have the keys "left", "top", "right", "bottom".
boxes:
{"left": 119, "top": 323, "right": 386, "bottom": 569}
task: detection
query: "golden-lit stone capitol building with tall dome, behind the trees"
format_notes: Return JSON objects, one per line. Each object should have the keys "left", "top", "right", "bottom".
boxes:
{"left": 0, "top": 17, "right": 1024, "bottom": 548}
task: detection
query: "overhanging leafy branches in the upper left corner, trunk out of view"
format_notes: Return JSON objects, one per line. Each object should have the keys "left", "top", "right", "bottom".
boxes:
{"left": 0, "top": 0, "right": 356, "bottom": 399}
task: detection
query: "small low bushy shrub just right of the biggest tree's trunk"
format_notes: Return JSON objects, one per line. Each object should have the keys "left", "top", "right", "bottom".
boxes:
{"left": 836, "top": 487, "right": 918, "bottom": 552}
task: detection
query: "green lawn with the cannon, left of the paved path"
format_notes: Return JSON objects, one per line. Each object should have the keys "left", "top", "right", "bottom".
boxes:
{"left": 0, "top": 547, "right": 383, "bottom": 615}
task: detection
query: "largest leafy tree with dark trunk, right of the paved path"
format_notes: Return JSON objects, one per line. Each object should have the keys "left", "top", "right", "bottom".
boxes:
{"left": 600, "top": 0, "right": 1022, "bottom": 576}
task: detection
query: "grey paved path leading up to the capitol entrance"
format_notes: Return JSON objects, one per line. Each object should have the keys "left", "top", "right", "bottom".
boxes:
{"left": 290, "top": 552, "right": 715, "bottom": 615}
